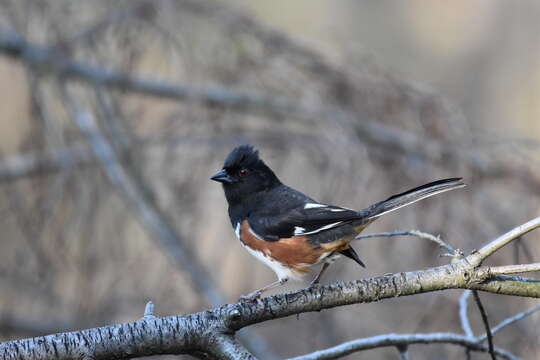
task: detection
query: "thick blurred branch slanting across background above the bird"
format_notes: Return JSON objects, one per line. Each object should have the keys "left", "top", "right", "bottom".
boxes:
{"left": 0, "top": 30, "right": 538, "bottom": 195}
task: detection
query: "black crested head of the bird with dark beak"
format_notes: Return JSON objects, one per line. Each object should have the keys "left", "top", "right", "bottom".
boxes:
{"left": 210, "top": 145, "right": 281, "bottom": 205}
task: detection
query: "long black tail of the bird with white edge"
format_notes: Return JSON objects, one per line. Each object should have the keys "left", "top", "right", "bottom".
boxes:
{"left": 362, "top": 178, "right": 465, "bottom": 220}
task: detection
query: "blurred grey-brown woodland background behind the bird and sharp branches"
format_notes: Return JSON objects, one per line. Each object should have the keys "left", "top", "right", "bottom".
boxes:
{"left": 0, "top": 0, "right": 540, "bottom": 359}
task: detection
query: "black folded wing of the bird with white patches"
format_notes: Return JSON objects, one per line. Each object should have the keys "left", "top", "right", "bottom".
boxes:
{"left": 249, "top": 202, "right": 364, "bottom": 241}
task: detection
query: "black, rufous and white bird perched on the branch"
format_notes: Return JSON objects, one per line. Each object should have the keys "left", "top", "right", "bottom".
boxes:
{"left": 210, "top": 144, "right": 465, "bottom": 301}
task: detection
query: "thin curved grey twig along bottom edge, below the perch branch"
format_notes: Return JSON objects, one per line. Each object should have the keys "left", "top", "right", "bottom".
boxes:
{"left": 289, "top": 333, "right": 518, "bottom": 360}
